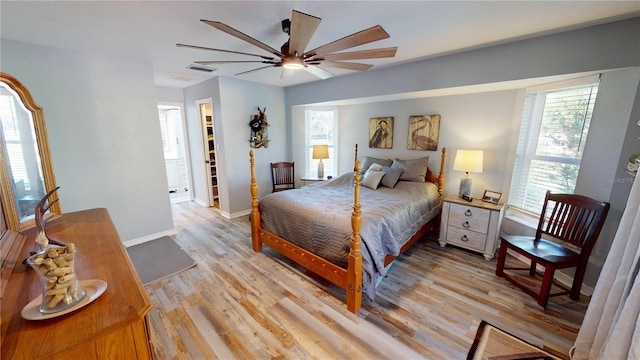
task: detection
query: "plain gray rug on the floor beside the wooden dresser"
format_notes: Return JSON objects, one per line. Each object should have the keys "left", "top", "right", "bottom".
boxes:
{"left": 127, "top": 236, "right": 196, "bottom": 285}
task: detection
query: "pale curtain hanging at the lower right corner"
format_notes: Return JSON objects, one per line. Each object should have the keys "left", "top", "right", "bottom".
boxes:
{"left": 571, "top": 181, "right": 640, "bottom": 360}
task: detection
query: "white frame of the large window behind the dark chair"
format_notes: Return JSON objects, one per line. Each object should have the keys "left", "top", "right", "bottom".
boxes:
{"left": 508, "top": 75, "right": 599, "bottom": 217}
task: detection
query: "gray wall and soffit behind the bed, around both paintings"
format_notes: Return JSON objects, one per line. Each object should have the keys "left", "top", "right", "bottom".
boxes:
{"left": 286, "top": 18, "right": 640, "bottom": 285}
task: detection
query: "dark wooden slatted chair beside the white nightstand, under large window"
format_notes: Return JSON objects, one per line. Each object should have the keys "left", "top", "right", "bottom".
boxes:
{"left": 496, "top": 191, "right": 609, "bottom": 307}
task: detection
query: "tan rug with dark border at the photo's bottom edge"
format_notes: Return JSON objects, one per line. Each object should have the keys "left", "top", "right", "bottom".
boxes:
{"left": 467, "top": 320, "right": 561, "bottom": 360}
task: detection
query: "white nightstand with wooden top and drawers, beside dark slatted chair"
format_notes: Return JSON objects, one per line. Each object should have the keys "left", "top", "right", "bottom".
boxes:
{"left": 438, "top": 195, "right": 504, "bottom": 260}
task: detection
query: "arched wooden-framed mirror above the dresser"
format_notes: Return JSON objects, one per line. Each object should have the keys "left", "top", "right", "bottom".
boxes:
{"left": 0, "top": 72, "right": 60, "bottom": 232}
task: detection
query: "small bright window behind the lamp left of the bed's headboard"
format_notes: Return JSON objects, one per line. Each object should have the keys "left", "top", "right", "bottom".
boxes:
{"left": 304, "top": 107, "right": 338, "bottom": 176}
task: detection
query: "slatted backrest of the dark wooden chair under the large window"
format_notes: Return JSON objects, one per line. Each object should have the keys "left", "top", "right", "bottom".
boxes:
{"left": 536, "top": 191, "right": 609, "bottom": 256}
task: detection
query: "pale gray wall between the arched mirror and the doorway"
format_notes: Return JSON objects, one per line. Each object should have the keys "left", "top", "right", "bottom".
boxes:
{"left": 0, "top": 39, "right": 173, "bottom": 241}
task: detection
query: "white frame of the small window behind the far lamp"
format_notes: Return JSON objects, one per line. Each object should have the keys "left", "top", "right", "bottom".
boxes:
{"left": 304, "top": 106, "right": 338, "bottom": 177}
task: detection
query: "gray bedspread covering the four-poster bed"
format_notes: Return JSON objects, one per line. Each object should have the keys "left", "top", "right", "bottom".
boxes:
{"left": 260, "top": 172, "right": 441, "bottom": 299}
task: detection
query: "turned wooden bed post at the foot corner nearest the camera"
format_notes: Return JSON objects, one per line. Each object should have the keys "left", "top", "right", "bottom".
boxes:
{"left": 347, "top": 144, "right": 362, "bottom": 313}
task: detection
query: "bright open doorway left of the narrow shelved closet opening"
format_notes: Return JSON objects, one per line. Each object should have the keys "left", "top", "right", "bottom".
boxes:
{"left": 158, "top": 103, "right": 193, "bottom": 204}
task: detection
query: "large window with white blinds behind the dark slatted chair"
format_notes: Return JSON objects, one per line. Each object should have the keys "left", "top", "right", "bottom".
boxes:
{"left": 509, "top": 77, "right": 598, "bottom": 214}
